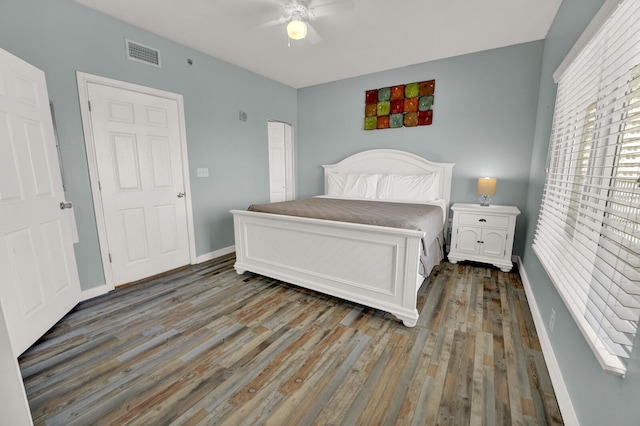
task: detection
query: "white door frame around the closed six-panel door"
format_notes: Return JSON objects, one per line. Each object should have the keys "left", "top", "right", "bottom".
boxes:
{"left": 76, "top": 71, "right": 196, "bottom": 291}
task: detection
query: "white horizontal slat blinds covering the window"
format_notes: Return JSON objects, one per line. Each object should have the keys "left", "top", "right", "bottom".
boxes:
{"left": 533, "top": 0, "right": 640, "bottom": 375}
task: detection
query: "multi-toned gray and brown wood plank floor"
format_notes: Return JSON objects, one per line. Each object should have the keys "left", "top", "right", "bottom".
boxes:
{"left": 19, "top": 256, "right": 562, "bottom": 426}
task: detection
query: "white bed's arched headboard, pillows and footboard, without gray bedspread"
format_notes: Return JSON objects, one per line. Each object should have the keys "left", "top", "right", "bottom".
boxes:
{"left": 231, "top": 149, "right": 454, "bottom": 327}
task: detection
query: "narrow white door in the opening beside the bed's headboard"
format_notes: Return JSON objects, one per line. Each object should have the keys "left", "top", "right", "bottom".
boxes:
{"left": 267, "top": 121, "right": 295, "bottom": 203}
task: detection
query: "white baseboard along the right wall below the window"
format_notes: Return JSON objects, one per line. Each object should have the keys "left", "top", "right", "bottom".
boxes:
{"left": 517, "top": 257, "right": 580, "bottom": 426}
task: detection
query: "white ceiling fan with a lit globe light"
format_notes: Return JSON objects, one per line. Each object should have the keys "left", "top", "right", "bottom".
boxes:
{"left": 265, "top": 0, "right": 353, "bottom": 44}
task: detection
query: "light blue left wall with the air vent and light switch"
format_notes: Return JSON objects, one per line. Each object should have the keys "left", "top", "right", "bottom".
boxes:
{"left": 0, "top": 0, "right": 297, "bottom": 290}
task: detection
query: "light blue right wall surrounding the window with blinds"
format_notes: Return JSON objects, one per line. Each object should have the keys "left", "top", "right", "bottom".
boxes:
{"left": 523, "top": 0, "right": 640, "bottom": 426}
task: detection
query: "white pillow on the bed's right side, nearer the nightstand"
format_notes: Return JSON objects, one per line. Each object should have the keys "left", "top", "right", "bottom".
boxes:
{"left": 376, "top": 172, "right": 440, "bottom": 202}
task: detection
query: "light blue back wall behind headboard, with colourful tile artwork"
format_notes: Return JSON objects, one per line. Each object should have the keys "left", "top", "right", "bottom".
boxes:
{"left": 298, "top": 41, "right": 543, "bottom": 255}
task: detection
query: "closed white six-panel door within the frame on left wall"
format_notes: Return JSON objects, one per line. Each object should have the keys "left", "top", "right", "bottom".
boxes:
{"left": 88, "top": 83, "right": 190, "bottom": 285}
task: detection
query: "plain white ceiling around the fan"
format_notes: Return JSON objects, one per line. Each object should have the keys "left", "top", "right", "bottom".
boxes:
{"left": 75, "top": 0, "right": 562, "bottom": 88}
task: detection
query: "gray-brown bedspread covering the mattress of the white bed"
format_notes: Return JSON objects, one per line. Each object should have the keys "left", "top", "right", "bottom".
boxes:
{"left": 248, "top": 197, "right": 443, "bottom": 270}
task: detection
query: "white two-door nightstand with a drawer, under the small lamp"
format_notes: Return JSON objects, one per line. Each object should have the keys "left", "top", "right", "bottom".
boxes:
{"left": 448, "top": 203, "right": 520, "bottom": 272}
